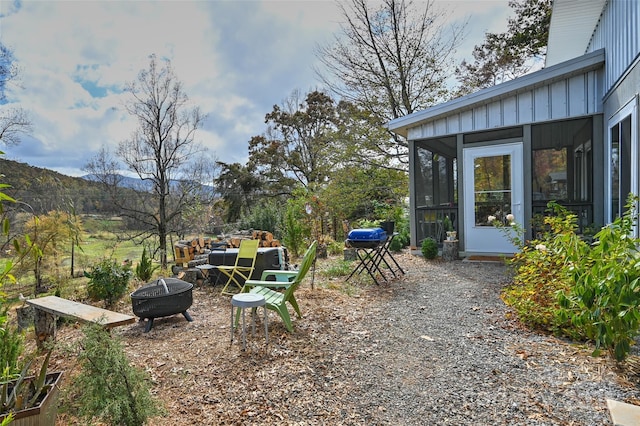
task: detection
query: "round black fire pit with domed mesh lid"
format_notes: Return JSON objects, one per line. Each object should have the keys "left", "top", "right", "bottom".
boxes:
{"left": 131, "top": 278, "right": 193, "bottom": 333}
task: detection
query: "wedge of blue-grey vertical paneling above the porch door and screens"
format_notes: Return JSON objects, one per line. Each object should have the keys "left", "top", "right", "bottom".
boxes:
{"left": 408, "top": 70, "right": 602, "bottom": 140}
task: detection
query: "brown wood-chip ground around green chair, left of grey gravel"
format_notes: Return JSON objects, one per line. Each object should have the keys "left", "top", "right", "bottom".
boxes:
{"left": 35, "top": 251, "right": 404, "bottom": 426}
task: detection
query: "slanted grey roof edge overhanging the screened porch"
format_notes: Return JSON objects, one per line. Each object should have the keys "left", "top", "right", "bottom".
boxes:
{"left": 387, "top": 49, "right": 604, "bottom": 138}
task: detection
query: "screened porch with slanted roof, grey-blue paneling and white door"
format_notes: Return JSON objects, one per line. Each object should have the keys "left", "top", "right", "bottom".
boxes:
{"left": 389, "top": 50, "right": 605, "bottom": 255}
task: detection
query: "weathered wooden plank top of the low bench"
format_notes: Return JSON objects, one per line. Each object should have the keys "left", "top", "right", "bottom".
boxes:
{"left": 27, "top": 296, "right": 136, "bottom": 328}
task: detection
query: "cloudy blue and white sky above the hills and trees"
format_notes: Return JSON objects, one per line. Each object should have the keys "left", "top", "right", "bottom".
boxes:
{"left": 0, "top": 0, "right": 512, "bottom": 176}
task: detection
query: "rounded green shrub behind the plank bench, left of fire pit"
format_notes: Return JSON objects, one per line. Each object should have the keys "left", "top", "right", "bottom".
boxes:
{"left": 84, "top": 259, "right": 133, "bottom": 306}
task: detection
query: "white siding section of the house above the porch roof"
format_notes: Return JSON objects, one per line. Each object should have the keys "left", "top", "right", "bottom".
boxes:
{"left": 545, "top": 0, "right": 607, "bottom": 66}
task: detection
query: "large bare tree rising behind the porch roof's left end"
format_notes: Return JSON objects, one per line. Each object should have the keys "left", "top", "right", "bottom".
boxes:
{"left": 316, "top": 0, "right": 464, "bottom": 161}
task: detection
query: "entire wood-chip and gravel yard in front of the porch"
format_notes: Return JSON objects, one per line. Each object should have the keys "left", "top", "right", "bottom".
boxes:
{"left": 13, "top": 253, "right": 639, "bottom": 426}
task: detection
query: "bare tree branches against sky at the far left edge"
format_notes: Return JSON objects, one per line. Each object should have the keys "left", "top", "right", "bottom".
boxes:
{"left": 0, "top": 43, "right": 31, "bottom": 145}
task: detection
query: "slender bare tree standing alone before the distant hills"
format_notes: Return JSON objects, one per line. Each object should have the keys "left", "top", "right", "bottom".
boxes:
{"left": 85, "top": 56, "right": 215, "bottom": 267}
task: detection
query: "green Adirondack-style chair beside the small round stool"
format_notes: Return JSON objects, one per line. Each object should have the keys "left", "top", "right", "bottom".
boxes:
{"left": 236, "top": 241, "right": 318, "bottom": 332}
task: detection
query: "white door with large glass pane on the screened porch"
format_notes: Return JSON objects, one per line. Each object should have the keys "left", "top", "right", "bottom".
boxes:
{"left": 463, "top": 142, "right": 524, "bottom": 253}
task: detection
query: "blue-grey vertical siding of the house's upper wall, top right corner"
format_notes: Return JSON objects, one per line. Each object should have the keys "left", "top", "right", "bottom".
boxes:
{"left": 585, "top": 0, "right": 640, "bottom": 93}
